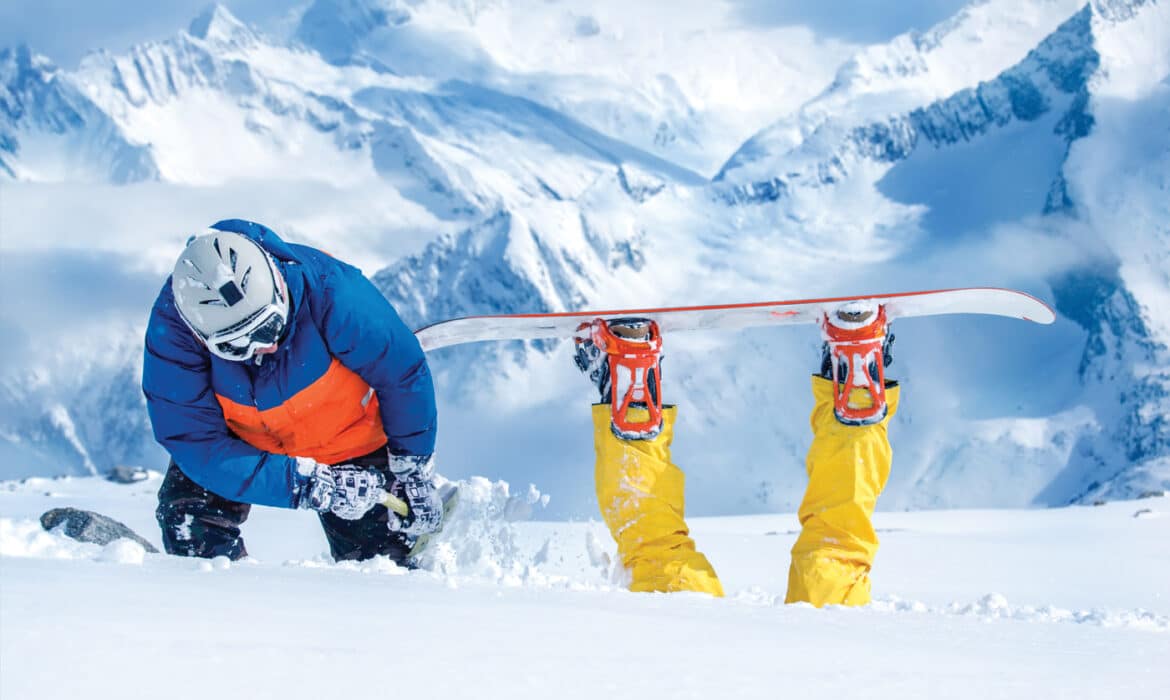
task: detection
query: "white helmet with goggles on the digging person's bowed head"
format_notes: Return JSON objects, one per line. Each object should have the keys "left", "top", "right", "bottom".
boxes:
{"left": 171, "top": 228, "right": 289, "bottom": 362}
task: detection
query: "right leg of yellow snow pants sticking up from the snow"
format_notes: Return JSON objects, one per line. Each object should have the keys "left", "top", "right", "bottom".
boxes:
{"left": 785, "top": 377, "right": 899, "bottom": 608}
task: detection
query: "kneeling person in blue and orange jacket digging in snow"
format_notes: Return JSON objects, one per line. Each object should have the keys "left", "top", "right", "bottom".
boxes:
{"left": 143, "top": 219, "right": 442, "bottom": 564}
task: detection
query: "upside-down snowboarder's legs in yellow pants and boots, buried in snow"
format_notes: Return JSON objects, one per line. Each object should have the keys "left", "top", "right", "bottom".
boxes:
{"left": 574, "top": 304, "right": 899, "bottom": 608}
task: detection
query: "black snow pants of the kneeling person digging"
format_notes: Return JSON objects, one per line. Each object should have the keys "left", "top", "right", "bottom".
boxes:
{"left": 154, "top": 448, "right": 410, "bottom": 564}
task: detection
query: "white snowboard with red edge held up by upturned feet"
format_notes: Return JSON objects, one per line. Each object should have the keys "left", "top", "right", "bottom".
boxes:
{"left": 414, "top": 287, "right": 1057, "bottom": 351}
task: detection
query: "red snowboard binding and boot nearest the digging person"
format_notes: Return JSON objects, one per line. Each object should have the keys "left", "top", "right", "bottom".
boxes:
{"left": 573, "top": 318, "right": 662, "bottom": 440}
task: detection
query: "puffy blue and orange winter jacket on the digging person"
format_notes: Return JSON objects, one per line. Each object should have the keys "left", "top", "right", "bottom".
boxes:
{"left": 143, "top": 219, "right": 435, "bottom": 508}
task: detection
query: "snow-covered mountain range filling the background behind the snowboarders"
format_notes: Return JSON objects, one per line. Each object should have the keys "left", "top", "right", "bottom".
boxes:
{"left": 0, "top": 0, "right": 1170, "bottom": 515}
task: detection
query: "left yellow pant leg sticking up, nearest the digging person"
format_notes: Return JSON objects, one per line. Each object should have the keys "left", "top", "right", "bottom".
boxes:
{"left": 593, "top": 404, "right": 723, "bottom": 596}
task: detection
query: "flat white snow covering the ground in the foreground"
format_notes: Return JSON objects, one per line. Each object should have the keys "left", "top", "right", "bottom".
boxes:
{"left": 0, "top": 473, "right": 1170, "bottom": 700}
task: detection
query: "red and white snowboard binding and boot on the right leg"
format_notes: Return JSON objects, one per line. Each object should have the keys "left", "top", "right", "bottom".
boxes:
{"left": 820, "top": 301, "right": 895, "bottom": 425}
